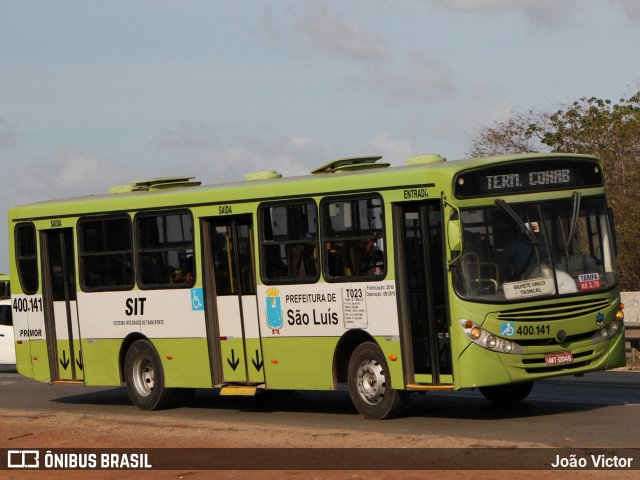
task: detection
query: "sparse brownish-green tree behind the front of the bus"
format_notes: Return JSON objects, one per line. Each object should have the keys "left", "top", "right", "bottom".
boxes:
{"left": 470, "top": 91, "right": 640, "bottom": 291}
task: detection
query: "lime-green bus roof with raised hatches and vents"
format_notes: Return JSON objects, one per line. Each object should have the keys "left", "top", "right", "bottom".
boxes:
{"left": 10, "top": 153, "right": 596, "bottom": 221}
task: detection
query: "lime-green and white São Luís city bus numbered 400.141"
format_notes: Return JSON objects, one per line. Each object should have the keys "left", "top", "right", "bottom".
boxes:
{"left": 8, "top": 153, "right": 625, "bottom": 419}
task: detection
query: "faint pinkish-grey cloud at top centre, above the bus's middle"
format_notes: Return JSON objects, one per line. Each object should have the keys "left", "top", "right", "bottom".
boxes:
{"left": 298, "top": 2, "right": 388, "bottom": 60}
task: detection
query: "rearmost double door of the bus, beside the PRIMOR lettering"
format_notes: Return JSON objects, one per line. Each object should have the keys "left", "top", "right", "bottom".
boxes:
{"left": 40, "top": 228, "right": 84, "bottom": 381}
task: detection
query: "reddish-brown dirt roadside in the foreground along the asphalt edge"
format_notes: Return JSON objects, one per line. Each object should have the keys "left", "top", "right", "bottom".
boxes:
{"left": 0, "top": 409, "right": 640, "bottom": 480}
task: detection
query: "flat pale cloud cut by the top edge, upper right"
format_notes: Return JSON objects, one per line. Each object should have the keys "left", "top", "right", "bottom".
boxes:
{"left": 425, "top": 0, "right": 588, "bottom": 24}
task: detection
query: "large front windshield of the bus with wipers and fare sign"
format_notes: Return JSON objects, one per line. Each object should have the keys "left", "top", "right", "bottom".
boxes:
{"left": 453, "top": 193, "right": 617, "bottom": 301}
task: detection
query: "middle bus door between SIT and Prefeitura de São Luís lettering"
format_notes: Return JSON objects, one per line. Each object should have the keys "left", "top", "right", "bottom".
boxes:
{"left": 203, "top": 215, "right": 264, "bottom": 385}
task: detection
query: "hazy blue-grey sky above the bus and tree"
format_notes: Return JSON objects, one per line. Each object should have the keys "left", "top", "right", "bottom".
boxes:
{"left": 0, "top": 0, "right": 640, "bottom": 272}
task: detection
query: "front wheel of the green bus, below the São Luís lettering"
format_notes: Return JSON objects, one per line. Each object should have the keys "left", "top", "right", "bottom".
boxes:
{"left": 348, "top": 342, "right": 408, "bottom": 420}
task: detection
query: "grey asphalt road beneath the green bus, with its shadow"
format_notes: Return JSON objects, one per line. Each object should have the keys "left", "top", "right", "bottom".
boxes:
{"left": 0, "top": 366, "right": 640, "bottom": 448}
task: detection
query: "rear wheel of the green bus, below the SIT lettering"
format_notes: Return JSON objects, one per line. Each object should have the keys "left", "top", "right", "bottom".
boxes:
{"left": 124, "top": 340, "right": 176, "bottom": 410}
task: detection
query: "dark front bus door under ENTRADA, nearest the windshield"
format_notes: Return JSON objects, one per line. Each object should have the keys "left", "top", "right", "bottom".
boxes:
{"left": 394, "top": 200, "right": 453, "bottom": 386}
